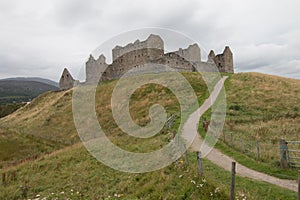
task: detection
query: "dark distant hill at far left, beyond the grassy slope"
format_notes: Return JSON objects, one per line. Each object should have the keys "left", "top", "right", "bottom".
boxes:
{"left": 0, "top": 79, "right": 59, "bottom": 104}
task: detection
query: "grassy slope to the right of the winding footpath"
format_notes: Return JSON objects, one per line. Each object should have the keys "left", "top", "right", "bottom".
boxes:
{"left": 198, "top": 73, "right": 300, "bottom": 179}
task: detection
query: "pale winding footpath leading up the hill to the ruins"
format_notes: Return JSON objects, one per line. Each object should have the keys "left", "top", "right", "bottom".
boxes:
{"left": 182, "top": 77, "right": 298, "bottom": 192}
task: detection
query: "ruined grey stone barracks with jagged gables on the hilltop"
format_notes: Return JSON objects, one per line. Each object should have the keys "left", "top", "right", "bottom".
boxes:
{"left": 59, "top": 34, "right": 234, "bottom": 90}
